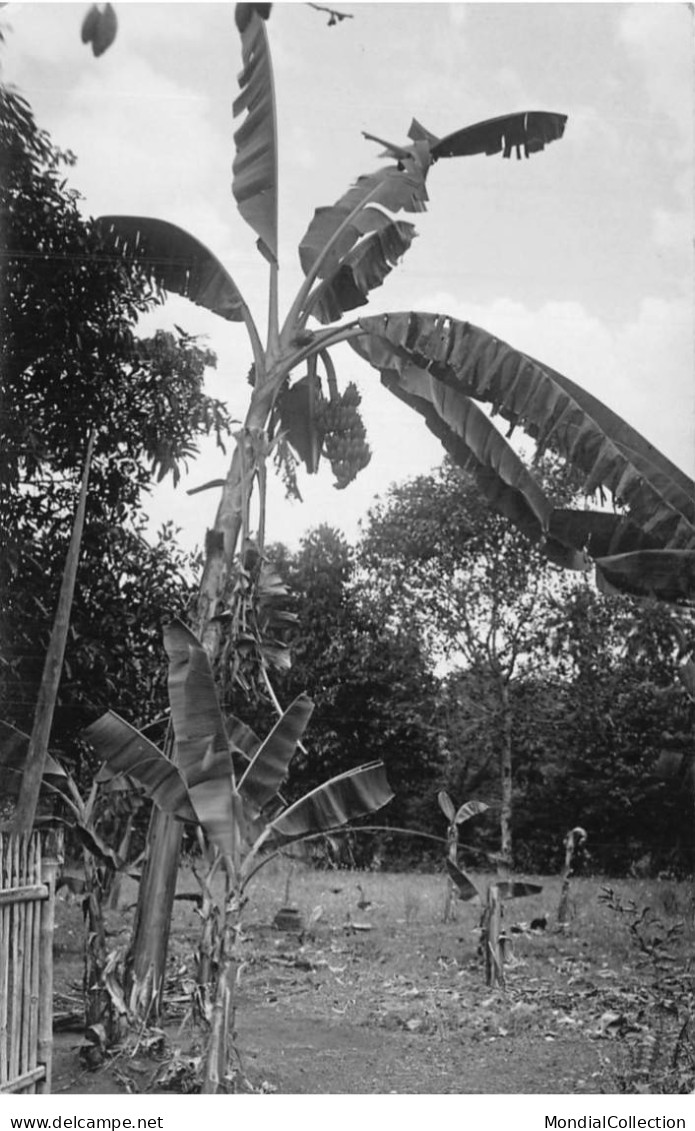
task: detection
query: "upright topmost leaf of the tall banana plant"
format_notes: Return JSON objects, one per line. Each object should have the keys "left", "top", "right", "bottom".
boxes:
{"left": 232, "top": 11, "right": 278, "bottom": 262}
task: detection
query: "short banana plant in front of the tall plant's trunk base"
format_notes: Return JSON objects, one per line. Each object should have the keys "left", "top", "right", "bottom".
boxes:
{"left": 85, "top": 620, "right": 393, "bottom": 1093}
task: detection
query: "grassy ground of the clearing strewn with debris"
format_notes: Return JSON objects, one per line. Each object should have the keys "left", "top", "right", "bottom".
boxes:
{"left": 50, "top": 862, "right": 695, "bottom": 1094}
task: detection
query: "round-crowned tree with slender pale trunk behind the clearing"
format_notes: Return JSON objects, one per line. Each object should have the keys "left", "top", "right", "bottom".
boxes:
{"left": 362, "top": 461, "right": 576, "bottom": 865}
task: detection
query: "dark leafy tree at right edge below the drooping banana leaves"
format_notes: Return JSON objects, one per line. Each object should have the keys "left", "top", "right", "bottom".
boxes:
{"left": 533, "top": 588, "right": 695, "bottom": 873}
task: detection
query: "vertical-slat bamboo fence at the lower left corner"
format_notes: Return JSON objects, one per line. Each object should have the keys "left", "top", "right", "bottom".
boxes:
{"left": 0, "top": 832, "right": 55, "bottom": 1095}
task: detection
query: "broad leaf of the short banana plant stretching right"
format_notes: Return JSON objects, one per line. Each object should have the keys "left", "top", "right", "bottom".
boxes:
{"left": 268, "top": 762, "right": 393, "bottom": 845}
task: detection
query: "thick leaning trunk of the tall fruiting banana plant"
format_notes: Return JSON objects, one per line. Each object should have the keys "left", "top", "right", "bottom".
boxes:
{"left": 125, "top": 381, "right": 272, "bottom": 1021}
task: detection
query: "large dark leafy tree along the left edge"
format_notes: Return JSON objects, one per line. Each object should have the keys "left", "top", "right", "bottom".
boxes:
{"left": 0, "top": 83, "right": 227, "bottom": 753}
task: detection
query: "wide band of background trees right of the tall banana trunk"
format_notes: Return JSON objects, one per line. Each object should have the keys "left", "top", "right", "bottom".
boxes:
{"left": 265, "top": 465, "right": 695, "bottom": 874}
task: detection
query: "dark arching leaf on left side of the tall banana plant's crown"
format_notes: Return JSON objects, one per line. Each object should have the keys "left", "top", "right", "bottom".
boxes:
{"left": 95, "top": 216, "right": 246, "bottom": 322}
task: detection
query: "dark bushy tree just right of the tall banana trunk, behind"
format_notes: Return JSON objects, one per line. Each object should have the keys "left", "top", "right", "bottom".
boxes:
{"left": 267, "top": 526, "right": 438, "bottom": 852}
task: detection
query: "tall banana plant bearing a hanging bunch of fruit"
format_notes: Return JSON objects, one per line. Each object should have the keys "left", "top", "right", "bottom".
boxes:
{"left": 93, "top": 3, "right": 695, "bottom": 1015}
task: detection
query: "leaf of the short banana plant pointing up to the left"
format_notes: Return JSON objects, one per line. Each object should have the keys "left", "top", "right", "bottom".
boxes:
{"left": 84, "top": 711, "right": 198, "bottom": 822}
